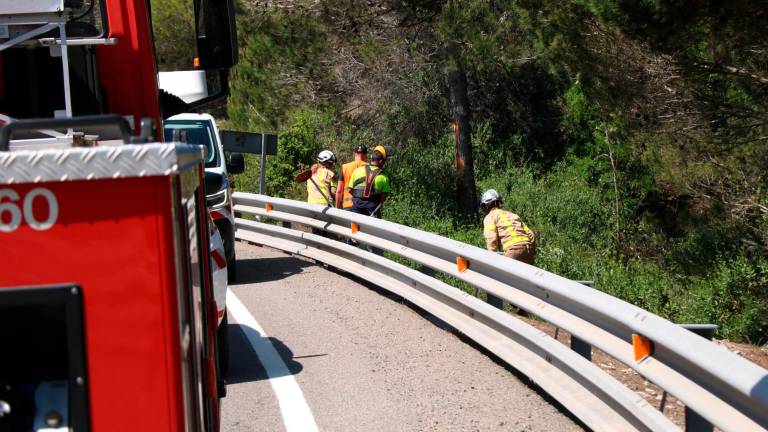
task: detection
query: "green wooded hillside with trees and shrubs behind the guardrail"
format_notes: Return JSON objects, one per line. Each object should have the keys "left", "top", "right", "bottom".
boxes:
{"left": 153, "top": 0, "right": 768, "bottom": 343}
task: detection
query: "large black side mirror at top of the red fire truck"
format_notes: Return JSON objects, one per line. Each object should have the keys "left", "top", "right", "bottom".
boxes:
{"left": 195, "top": 0, "right": 237, "bottom": 70}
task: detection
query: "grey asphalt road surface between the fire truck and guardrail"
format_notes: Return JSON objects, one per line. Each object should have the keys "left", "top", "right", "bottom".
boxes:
{"left": 222, "top": 242, "right": 582, "bottom": 432}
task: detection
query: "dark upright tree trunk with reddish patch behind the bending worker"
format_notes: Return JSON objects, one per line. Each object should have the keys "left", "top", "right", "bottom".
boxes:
{"left": 447, "top": 56, "right": 477, "bottom": 220}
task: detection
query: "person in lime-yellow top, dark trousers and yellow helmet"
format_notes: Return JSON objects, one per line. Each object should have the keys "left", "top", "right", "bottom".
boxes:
{"left": 347, "top": 146, "right": 392, "bottom": 217}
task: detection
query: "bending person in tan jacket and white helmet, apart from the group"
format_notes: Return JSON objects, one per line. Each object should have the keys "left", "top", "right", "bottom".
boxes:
{"left": 480, "top": 189, "right": 536, "bottom": 264}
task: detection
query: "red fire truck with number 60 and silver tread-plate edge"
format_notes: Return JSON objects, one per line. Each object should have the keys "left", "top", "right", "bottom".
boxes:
{"left": 0, "top": 0, "right": 237, "bottom": 432}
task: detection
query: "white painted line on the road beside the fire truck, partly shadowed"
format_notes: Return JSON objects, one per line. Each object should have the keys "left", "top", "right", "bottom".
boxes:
{"left": 227, "top": 290, "right": 318, "bottom": 432}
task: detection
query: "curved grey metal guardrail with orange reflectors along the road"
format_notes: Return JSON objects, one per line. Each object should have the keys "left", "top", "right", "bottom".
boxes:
{"left": 234, "top": 192, "right": 768, "bottom": 432}
